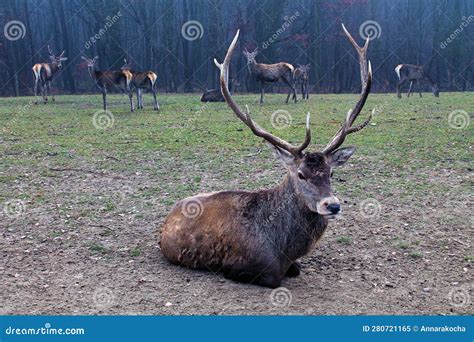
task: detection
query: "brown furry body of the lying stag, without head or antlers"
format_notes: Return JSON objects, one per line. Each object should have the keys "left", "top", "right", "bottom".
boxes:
{"left": 160, "top": 172, "right": 328, "bottom": 287}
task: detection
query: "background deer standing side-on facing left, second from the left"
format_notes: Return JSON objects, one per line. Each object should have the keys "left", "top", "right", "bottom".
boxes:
{"left": 81, "top": 56, "right": 134, "bottom": 112}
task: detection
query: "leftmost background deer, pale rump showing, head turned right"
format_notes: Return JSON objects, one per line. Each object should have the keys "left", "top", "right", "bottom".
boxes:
{"left": 33, "top": 45, "right": 67, "bottom": 104}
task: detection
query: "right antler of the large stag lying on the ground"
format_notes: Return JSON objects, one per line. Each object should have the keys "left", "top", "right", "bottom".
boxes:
{"left": 322, "top": 24, "right": 373, "bottom": 154}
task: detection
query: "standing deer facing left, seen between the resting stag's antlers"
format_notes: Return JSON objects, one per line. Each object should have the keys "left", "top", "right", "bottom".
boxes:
{"left": 244, "top": 49, "right": 297, "bottom": 104}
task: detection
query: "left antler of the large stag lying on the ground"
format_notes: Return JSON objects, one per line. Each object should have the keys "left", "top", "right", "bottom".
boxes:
{"left": 214, "top": 30, "right": 311, "bottom": 157}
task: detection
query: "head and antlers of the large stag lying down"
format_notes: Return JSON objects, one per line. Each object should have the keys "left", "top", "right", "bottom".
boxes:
{"left": 214, "top": 31, "right": 372, "bottom": 218}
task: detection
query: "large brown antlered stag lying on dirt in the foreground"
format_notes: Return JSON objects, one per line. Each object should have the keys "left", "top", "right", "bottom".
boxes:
{"left": 160, "top": 31, "right": 372, "bottom": 288}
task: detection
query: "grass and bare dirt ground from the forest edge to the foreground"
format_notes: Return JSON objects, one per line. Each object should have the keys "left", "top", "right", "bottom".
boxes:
{"left": 0, "top": 93, "right": 474, "bottom": 315}
